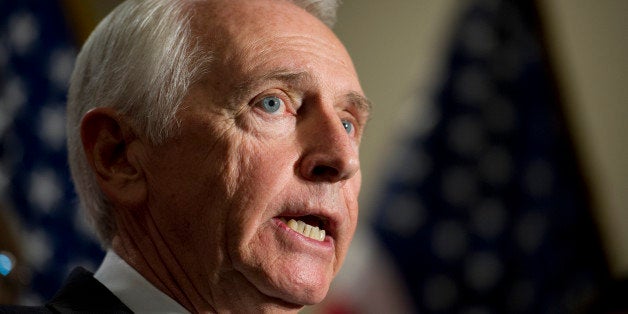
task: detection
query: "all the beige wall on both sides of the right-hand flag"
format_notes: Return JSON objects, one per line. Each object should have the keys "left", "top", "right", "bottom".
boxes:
{"left": 336, "top": 0, "right": 628, "bottom": 276}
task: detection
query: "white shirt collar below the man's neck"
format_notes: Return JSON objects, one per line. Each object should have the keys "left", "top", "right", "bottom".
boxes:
{"left": 94, "top": 250, "right": 189, "bottom": 314}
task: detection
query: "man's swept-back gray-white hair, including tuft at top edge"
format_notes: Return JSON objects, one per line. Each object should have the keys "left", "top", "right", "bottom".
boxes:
{"left": 67, "top": 0, "right": 339, "bottom": 247}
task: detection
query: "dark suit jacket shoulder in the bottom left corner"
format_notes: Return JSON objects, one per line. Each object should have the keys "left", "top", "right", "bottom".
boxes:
{"left": 0, "top": 267, "right": 133, "bottom": 313}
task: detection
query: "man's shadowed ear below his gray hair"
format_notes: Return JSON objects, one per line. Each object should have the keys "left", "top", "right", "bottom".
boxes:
{"left": 81, "top": 108, "right": 146, "bottom": 208}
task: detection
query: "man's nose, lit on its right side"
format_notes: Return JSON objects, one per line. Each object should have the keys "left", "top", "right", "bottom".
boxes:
{"left": 298, "top": 106, "right": 360, "bottom": 183}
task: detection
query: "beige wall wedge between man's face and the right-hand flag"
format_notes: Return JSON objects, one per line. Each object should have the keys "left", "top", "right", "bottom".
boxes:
{"left": 334, "top": 0, "right": 465, "bottom": 218}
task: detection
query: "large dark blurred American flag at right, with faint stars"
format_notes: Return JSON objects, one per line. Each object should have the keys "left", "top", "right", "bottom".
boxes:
{"left": 374, "top": 0, "right": 609, "bottom": 313}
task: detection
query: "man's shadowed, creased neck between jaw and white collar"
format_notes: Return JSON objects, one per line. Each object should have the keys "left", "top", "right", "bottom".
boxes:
{"left": 111, "top": 212, "right": 302, "bottom": 313}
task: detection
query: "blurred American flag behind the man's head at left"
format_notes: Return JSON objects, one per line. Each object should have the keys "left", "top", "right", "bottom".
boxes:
{"left": 0, "top": 0, "right": 104, "bottom": 304}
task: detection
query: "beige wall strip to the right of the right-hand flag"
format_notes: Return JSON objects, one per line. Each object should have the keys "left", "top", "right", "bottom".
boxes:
{"left": 541, "top": 0, "right": 628, "bottom": 277}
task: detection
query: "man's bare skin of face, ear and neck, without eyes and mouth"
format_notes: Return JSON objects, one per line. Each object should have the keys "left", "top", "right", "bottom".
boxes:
{"left": 81, "top": 0, "right": 368, "bottom": 312}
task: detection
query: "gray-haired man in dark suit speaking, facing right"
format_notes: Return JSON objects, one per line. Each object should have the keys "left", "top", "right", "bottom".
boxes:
{"left": 0, "top": 0, "right": 369, "bottom": 313}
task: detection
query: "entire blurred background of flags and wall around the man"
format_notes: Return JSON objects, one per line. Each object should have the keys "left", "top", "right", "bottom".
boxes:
{"left": 0, "top": 0, "right": 628, "bottom": 313}
